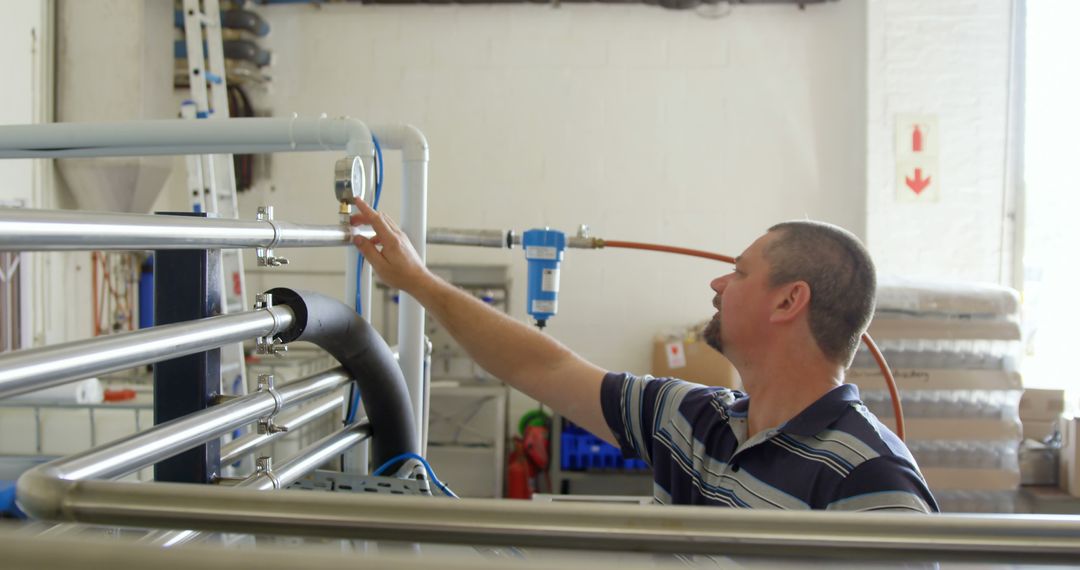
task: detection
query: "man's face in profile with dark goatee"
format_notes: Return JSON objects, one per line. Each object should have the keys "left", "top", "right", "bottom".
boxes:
{"left": 704, "top": 232, "right": 775, "bottom": 357}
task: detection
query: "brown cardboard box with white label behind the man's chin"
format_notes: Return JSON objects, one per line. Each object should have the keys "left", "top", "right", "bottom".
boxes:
{"left": 651, "top": 340, "right": 742, "bottom": 390}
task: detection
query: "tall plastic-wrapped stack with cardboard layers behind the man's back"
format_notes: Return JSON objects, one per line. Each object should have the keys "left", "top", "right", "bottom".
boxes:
{"left": 848, "top": 280, "right": 1023, "bottom": 512}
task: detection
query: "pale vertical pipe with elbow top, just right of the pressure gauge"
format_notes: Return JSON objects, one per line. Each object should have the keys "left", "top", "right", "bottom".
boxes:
{"left": 372, "top": 124, "right": 429, "bottom": 454}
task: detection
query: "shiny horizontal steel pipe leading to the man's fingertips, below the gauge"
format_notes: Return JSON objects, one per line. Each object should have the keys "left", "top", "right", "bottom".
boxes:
{"left": 0, "top": 208, "right": 375, "bottom": 252}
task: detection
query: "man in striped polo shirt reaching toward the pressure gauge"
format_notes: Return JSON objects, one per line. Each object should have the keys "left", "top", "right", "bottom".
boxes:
{"left": 352, "top": 201, "right": 937, "bottom": 513}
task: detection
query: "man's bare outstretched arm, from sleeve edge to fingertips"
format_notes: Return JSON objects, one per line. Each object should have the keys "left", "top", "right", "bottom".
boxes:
{"left": 351, "top": 200, "right": 615, "bottom": 443}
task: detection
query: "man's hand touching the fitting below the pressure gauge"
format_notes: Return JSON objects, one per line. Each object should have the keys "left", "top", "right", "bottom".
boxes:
{"left": 349, "top": 198, "right": 433, "bottom": 293}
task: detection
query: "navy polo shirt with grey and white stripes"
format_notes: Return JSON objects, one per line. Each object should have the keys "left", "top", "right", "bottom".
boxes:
{"left": 600, "top": 372, "right": 939, "bottom": 513}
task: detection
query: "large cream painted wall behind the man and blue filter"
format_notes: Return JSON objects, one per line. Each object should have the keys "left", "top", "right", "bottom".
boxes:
{"left": 242, "top": 1, "right": 866, "bottom": 372}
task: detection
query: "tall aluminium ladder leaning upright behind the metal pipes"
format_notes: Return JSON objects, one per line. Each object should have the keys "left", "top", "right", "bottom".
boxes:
{"left": 180, "top": 0, "right": 251, "bottom": 401}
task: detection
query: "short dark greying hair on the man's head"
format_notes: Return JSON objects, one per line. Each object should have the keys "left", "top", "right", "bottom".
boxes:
{"left": 765, "top": 220, "right": 877, "bottom": 367}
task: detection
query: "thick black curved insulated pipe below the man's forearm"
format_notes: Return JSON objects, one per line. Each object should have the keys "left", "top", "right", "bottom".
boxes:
{"left": 267, "top": 287, "right": 419, "bottom": 473}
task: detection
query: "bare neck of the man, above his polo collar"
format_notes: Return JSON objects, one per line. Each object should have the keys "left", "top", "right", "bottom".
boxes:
{"left": 740, "top": 351, "right": 843, "bottom": 437}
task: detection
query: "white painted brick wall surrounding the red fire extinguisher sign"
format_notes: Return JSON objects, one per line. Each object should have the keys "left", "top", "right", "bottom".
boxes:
{"left": 866, "top": 0, "right": 1012, "bottom": 282}
